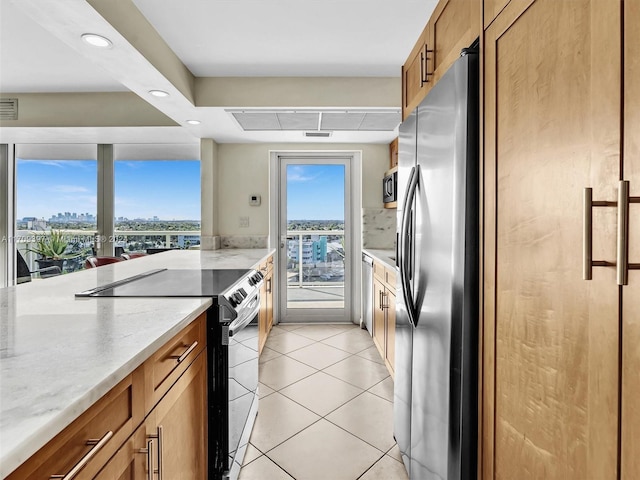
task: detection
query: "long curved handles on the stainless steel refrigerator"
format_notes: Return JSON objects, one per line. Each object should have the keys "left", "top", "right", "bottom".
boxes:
{"left": 400, "top": 165, "right": 420, "bottom": 327}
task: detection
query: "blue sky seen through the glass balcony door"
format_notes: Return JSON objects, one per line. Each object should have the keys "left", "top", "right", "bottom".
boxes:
{"left": 287, "top": 165, "right": 344, "bottom": 220}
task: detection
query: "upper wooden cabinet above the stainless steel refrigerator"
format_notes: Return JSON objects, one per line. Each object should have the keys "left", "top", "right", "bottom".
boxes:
{"left": 402, "top": 0, "right": 482, "bottom": 120}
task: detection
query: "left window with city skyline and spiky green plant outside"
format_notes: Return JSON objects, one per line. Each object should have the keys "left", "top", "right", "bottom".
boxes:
{"left": 15, "top": 145, "right": 98, "bottom": 273}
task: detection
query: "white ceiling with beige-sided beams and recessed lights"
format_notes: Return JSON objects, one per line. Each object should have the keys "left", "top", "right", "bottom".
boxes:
{"left": 0, "top": 0, "right": 436, "bottom": 143}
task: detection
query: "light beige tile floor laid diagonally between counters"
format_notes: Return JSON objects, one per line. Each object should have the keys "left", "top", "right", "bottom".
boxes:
{"left": 240, "top": 324, "right": 407, "bottom": 480}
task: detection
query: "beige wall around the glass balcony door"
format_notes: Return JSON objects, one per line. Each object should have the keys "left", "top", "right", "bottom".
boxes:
{"left": 218, "top": 143, "right": 389, "bottom": 235}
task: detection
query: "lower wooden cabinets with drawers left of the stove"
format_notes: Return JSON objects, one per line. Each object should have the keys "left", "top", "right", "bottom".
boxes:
{"left": 7, "top": 314, "right": 207, "bottom": 480}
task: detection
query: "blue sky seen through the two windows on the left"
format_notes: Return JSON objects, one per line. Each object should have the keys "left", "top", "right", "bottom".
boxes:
{"left": 16, "top": 159, "right": 200, "bottom": 220}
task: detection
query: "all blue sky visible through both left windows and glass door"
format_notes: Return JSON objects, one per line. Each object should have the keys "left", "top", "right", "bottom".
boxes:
{"left": 16, "top": 159, "right": 345, "bottom": 223}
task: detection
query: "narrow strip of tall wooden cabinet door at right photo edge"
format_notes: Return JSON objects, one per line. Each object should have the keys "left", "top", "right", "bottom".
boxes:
{"left": 621, "top": 0, "right": 640, "bottom": 480}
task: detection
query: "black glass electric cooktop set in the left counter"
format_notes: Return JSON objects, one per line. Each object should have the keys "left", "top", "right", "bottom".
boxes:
{"left": 76, "top": 269, "right": 250, "bottom": 297}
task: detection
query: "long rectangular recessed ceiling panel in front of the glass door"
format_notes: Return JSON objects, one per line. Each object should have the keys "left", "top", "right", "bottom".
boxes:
{"left": 226, "top": 108, "right": 402, "bottom": 132}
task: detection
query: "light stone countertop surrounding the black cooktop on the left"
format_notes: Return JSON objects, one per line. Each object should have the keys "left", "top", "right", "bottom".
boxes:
{"left": 0, "top": 249, "right": 274, "bottom": 478}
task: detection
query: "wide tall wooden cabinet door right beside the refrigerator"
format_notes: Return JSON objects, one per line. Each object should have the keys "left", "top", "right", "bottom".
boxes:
{"left": 481, "top": 0, "right": 621, "bottom": 480}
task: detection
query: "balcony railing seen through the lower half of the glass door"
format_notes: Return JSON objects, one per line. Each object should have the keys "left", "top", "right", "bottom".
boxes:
{"left": 286, "top": 230, "right": 344, "bottom": 288}
